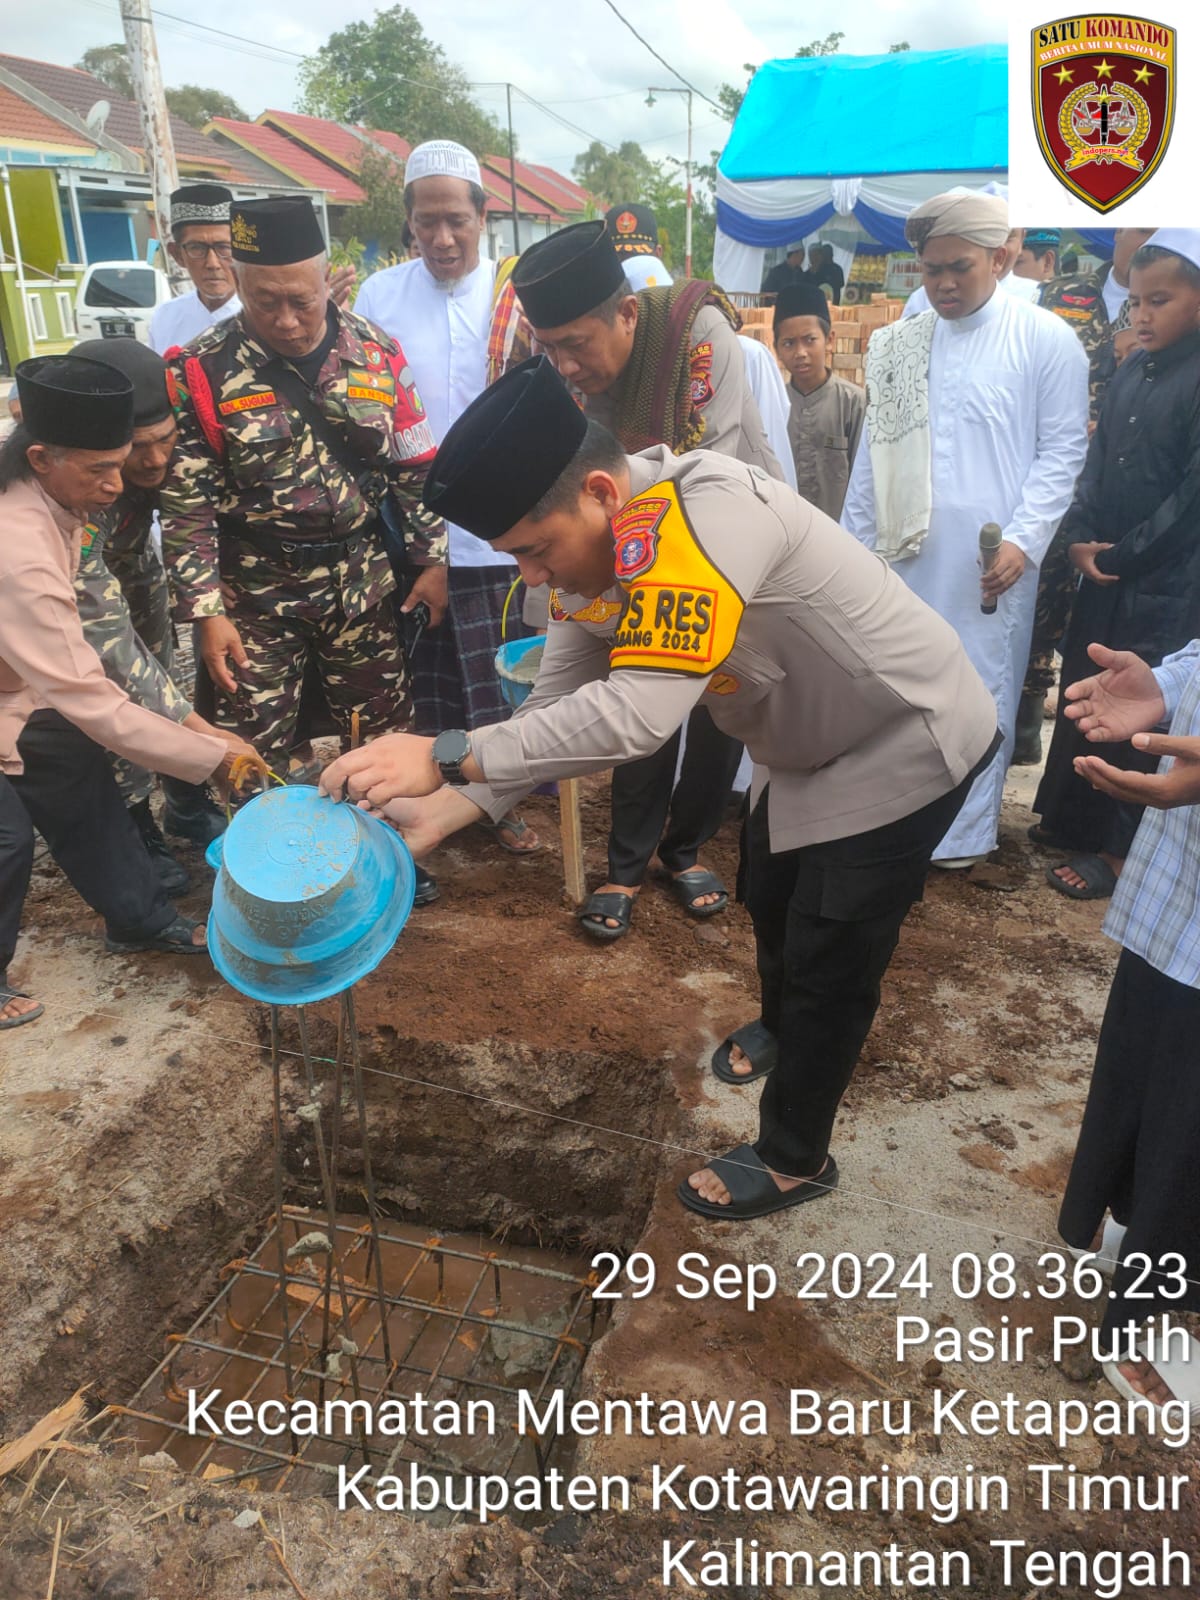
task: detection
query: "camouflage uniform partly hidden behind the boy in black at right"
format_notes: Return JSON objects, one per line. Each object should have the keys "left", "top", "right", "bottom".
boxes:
{"left": 1022, "top": 264, "right": 1130, "bottom": 696}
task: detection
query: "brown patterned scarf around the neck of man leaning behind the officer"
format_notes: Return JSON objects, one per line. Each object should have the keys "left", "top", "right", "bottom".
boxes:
{"left": 613, "top": 278, "right": 742, "bottom": 456}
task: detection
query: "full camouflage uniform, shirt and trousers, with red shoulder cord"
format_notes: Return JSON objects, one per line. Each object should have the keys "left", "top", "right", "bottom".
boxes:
{"left": 162, "top": 310, "right": 446, "bottom": 774}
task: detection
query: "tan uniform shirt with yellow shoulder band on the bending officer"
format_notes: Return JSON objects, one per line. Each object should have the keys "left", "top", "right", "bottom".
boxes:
{"left": 466, "top": 446, "right": 995, "bottom": 851}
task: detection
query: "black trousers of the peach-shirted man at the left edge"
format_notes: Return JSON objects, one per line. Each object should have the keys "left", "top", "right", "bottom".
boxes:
{"left": 0, "top": 710, "right": 174, "bottom": 979}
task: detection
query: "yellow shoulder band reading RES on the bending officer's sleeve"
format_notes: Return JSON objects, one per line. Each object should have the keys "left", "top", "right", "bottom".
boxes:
{"left": 610, "top": 483, "right": 744, "bottom": 677}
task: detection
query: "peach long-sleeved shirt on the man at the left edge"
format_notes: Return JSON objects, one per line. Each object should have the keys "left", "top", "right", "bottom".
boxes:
{"left": 0, "top": 482, "right": 226, "bottom": 782}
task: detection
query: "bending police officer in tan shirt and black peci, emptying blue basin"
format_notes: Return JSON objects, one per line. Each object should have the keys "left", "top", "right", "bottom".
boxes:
{"left": 322, "top": 360, "right": 998, "bottom": 1218}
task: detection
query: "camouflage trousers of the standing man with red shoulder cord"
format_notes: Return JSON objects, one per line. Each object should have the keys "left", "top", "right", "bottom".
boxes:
{"left": 216, "top": 568, "right": 413, "bottom": 778}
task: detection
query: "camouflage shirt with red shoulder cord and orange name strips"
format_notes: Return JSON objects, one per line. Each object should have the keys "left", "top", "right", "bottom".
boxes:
{"left": 162, "top": 310, "right": 446, "bottom": 621}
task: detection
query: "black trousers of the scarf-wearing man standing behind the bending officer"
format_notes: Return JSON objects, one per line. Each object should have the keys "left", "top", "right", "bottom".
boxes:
{"left": 608, "top": 706, "right": 742, "bottom": 888}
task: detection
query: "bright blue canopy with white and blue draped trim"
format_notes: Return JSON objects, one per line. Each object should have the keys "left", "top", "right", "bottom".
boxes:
{"left": 715, "top": 45, "right": 1008, "bottom": 291}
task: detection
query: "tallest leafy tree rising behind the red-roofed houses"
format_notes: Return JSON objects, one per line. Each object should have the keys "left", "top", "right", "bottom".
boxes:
{"left": 299, "top": 5, "right": 509, "bottom": 155}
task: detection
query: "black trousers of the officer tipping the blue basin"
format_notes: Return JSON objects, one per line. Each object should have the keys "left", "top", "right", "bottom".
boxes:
{"left": 744, "top": 742, "right": 998, "bottom": 1178}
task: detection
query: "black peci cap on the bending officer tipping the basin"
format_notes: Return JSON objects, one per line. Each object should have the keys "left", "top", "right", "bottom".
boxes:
{"left": 422, "top": 355, "right": 587, "bottom": 539}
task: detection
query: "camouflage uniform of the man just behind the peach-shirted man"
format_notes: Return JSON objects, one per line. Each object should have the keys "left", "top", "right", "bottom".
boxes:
{"left": 75, "top": 508, "right": 192, "bottom": 806}
